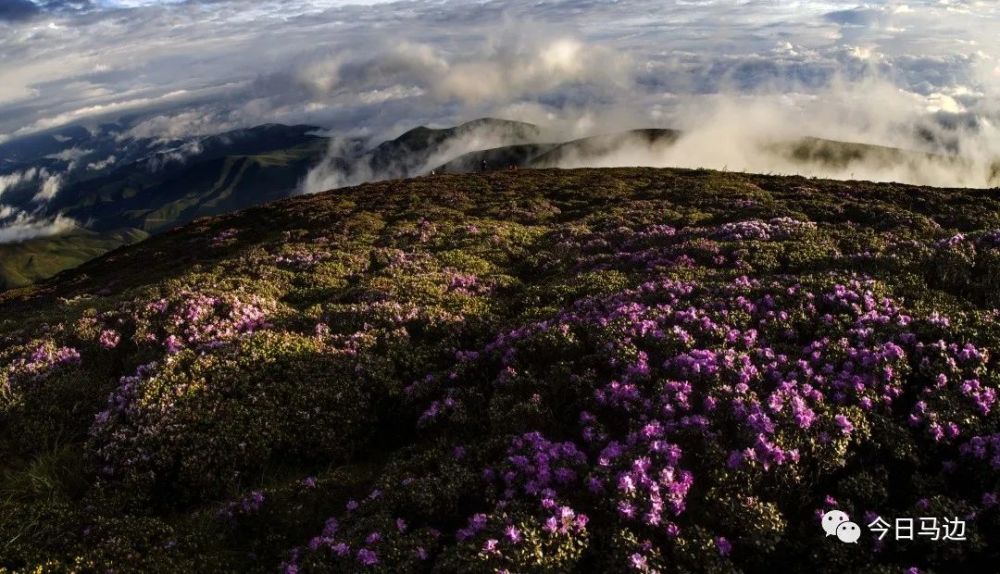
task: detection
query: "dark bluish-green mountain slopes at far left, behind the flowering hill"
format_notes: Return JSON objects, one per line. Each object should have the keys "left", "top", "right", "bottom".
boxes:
{"left": 0, "top": 124, "right": 328, "bottom": 288}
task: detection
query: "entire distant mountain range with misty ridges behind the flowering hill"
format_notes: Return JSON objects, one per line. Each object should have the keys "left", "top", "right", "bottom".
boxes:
{"left": 0, "top": 118, "right": 1000, "bottom": 289}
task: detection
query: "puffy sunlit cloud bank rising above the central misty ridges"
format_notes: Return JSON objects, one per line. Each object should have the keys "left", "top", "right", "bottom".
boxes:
{"left": 292, "top": 29, "right": 634, "bottom": 119}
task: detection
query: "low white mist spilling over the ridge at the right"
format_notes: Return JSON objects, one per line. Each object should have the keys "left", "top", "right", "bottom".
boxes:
{"left": 544, "top": 80, "right": 1000, "bottom": 187}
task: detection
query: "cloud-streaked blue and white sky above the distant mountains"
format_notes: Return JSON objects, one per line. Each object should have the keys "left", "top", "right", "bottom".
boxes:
{"left": 0, "top": 0, "right": 1000, "bottom": 152}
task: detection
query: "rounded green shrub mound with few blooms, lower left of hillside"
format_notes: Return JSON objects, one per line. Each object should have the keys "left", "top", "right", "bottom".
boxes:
{"left": 89, "top": 333, "right": 371, "bottom": 502}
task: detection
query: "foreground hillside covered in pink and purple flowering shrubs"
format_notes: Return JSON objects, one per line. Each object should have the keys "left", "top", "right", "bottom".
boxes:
{"left": 0, "top": 169, "right": 1000, "bottom": 573}
